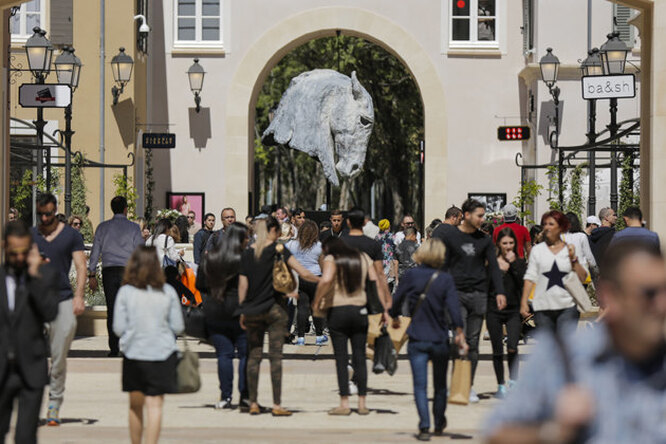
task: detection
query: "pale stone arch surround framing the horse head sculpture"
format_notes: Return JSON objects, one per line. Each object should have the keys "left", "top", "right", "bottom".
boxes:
{"left": 224, "top": 7, "right": 447, "bottom": 224}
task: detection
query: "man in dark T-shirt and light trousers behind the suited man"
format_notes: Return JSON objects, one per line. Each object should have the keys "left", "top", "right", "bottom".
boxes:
{"left": 32, "top": 193, "right": 86, "bottom": 426}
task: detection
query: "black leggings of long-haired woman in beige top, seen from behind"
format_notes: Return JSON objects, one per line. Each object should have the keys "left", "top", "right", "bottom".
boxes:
{"left": 328, "top": 305, "right": 368, "bottom": 396}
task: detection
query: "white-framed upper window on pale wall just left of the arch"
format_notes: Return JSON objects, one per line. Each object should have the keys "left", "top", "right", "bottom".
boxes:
{"left": 174, "top": 0, "right": 222, "bottom": 48}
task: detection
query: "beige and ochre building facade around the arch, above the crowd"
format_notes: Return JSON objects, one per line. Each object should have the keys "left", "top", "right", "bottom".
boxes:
{"left": 3, "top": 0, "right": 666, "bottom": 236}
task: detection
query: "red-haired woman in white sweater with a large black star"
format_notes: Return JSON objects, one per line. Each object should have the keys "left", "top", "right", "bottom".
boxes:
{"left": 520, "top": 210, "right": 587, "bottom": 331}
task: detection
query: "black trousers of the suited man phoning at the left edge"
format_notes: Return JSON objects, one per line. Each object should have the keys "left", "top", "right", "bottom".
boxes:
{"left": 0, "top": 365, "right": 44, "bottom": 444}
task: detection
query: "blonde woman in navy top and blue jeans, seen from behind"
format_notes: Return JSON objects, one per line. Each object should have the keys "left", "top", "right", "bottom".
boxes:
{"left": 391, "top": 238, "right": 468, "bottom": 441}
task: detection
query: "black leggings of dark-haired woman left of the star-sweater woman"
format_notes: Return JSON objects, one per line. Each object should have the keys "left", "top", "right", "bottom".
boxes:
{"left": 486, "top": 310, "right": 521, "bottom": 384}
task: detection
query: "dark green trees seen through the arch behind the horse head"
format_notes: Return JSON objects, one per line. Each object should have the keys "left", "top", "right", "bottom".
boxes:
{"left": 254, "top": 36, "right": 424, "bottom": 224}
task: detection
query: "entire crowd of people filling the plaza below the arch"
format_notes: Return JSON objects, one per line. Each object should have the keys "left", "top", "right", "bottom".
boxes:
{"left": 0, "top": 194, "right": 666, "bottom": 443}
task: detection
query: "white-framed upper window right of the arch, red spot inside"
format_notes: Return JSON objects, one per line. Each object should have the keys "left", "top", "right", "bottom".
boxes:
{"left": 449, "top": 0, "right": 499, "bottom": 48}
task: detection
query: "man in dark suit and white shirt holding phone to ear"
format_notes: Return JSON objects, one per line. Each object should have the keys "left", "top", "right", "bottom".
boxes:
{"left": 0, "top": 221, "right": 58, "bottom": 443}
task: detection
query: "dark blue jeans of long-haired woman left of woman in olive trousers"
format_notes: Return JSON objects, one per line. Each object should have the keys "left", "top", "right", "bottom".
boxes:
{"left": 209, "top": 321, "right": 249, "bottom": 400}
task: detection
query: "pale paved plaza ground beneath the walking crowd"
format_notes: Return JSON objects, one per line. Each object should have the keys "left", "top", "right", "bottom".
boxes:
{"left": 26, "top": 336, "right": 527, "bottom": 444}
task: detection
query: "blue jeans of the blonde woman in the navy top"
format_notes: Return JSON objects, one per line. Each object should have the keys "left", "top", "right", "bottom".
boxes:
{"left": 407, "top": 339, "right": 449, "bottom": 430}
